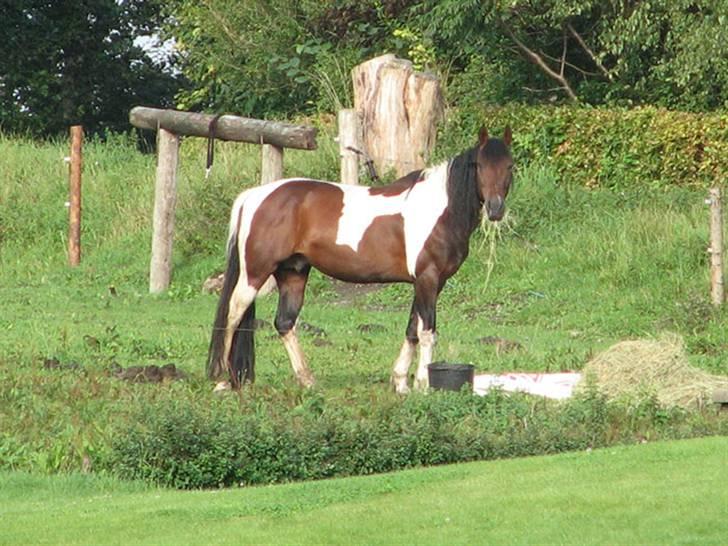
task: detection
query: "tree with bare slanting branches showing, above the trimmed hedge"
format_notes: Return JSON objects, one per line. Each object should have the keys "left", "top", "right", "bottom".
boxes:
{"left": 421, "top": 0, "right": 728, "bottom": 110}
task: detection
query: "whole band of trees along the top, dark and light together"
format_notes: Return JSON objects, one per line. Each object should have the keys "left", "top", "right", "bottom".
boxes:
{"left": 7, "top": 0, "right": 728, "bottom": 136}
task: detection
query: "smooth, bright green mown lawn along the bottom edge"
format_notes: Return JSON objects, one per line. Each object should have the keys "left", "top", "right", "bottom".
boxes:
{"left": 0, "top": 437, "right": 728, "bottom": 545}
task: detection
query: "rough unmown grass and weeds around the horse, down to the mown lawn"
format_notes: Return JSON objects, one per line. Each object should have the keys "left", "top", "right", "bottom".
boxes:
{"left": 0, "top": 125, "right": 728, "bottom": 480}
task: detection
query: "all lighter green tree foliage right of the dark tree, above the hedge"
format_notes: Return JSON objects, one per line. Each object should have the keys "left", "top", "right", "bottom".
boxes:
{"left": 169, "top": 0, "right": 728, "bottom": 115}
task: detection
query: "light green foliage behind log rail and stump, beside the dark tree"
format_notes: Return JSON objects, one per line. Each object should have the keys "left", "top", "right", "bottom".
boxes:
{"left": 167, "top": 0, "right": 424, "bottom": 117}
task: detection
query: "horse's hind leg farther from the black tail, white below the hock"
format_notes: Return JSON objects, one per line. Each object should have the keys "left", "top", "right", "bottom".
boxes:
{"left": 274, "top": 257, "right": 314, "bottom": 387}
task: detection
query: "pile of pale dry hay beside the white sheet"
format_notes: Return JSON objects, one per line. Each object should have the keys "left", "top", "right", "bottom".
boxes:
{"left": 584, "top": 336, "right": 728, "bottom": 408}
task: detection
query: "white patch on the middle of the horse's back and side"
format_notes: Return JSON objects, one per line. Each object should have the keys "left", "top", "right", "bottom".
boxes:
{"left": 336, "top": 185, "right": 405, "bottom": 252}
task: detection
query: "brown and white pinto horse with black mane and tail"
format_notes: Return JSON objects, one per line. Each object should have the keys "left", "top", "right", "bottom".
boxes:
{"left": 207, "top": 127, "right": 513, "bottom": 393}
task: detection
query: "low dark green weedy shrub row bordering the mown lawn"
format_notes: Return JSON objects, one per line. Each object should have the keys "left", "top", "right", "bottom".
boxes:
{"left": 105, "top": 386, "right": 728, "bottom": 488}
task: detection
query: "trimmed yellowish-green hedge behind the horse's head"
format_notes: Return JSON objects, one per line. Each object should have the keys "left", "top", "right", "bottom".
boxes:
{"left": 439, "top": 104, "right": 728, "bottom": 189}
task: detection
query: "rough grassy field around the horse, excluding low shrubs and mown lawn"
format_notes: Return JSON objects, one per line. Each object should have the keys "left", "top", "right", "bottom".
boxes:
{"left": 0, "top": 127, "right": 728, "bottom": 472}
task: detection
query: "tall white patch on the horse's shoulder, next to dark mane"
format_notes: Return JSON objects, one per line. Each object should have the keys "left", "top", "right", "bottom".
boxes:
{"left": 402, "top": 162, "right": 450, "bottom": 277}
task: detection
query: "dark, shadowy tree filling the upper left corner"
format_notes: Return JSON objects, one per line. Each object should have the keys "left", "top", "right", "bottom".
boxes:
{"left": 0, "top": 0, "right": 179, "bottom": 136}
